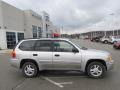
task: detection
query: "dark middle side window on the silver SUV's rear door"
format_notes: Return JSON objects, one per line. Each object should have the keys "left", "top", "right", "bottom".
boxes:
{"left": 35, "top": 40, "right": 52, "bottom": 51}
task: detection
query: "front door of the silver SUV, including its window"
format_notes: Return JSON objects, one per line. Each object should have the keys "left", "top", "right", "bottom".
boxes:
{"left": 53, "top": 40, "right": 81, "bottom": 70}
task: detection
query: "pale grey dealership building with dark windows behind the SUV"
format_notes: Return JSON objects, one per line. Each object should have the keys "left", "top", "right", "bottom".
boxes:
{"left": 0, "top": 1, "right": 60, "bottom": 49}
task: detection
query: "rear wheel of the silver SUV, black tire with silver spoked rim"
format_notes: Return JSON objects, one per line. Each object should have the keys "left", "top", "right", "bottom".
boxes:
{"left": 22, "top": 62, "right": 38, "bottom": 78}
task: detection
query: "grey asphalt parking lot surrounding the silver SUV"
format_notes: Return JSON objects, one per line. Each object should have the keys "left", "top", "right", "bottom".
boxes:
{"left": 0, "top": 39, "right": 120, "bottom": 90}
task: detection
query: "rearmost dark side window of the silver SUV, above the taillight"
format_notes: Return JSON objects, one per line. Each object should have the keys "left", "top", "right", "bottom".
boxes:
{"left": 19, "top": 40, "right": 35, "bottom": 51}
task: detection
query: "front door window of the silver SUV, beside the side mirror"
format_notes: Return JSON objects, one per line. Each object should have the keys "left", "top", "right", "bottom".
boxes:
{"left": 53, "top": 41, "right": 74, "bottom": 52}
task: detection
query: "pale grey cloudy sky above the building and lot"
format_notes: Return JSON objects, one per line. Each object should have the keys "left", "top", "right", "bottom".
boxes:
{"left": 3, "top": 0, "right": 120, "bottom": 33}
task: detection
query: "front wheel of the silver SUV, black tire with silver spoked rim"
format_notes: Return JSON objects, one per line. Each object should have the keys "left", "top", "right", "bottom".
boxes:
{"left": 87, "top": 62, "right": 106, "bottom": 79}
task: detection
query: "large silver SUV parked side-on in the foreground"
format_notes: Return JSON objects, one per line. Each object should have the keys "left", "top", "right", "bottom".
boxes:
{"left": 11, "top": 38, "right": 114, "bottom": 78}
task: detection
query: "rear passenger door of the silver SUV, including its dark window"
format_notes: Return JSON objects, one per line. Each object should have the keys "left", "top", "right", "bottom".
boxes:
{"left": 33, "top": 40, "right": 52, "bottom": 69}
